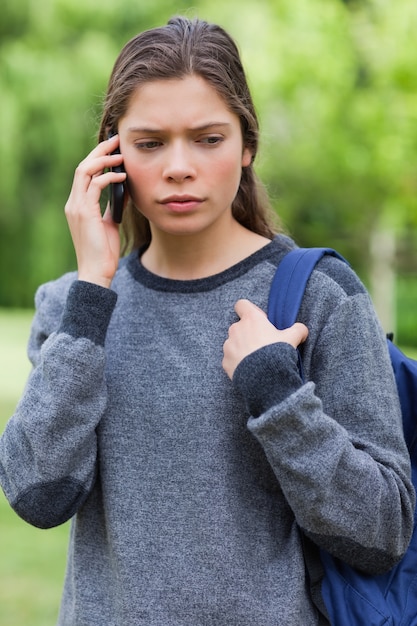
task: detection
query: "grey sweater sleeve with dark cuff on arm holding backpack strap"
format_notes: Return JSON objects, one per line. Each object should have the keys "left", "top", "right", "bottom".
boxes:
{"left": 233, "top": 260, "right": 415, "bottom": 574}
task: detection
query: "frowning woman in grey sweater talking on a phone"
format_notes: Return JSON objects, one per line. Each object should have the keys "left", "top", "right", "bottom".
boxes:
{"left": 0, "top": 18, "right": 414, "bottom": 626}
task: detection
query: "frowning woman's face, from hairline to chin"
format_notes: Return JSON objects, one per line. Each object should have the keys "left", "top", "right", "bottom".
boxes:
{"left": 118, "top": 75, "right": 251, "bottom": 235}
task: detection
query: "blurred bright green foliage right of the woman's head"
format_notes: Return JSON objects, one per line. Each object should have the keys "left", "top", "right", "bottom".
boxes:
{"left": 206, "top": 0, "right": 417, "bottom": 342}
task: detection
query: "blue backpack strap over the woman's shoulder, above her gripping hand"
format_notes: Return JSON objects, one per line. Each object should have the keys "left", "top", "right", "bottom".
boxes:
{"left": 268, "top": 248, "right": 347, "bottom": 330}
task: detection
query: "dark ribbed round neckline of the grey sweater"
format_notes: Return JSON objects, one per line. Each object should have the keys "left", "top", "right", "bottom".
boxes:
{"left": 127, "top": 235, "right": 292, "bottom": 293}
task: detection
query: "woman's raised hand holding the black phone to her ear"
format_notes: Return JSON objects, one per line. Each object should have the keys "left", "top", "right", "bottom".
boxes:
{"left": 65, "top": 135, "right": 126, "bottom": 287}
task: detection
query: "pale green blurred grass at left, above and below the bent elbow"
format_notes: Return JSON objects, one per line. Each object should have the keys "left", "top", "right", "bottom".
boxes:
{"left": 0, "top": 310, "right": 68, "bottom": 626}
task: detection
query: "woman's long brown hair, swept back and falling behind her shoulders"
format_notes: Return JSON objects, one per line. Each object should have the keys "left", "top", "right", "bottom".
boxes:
{"left": 99, "top": 17, "right": 277, "bottom": 251}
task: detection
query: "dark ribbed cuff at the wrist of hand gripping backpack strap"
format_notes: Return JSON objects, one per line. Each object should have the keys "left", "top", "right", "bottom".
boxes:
{"left": 233, "top": 343, "right": 303, "bottom": 417}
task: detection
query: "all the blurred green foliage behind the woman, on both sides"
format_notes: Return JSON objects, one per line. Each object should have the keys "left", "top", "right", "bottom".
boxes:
{"left": 0, "top": 0, "right": 417, "bottom": 322}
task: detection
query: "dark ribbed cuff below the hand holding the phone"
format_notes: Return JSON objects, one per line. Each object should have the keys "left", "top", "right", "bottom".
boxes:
{"left": 59, "top": 280, "right": 117, "bottom": 346}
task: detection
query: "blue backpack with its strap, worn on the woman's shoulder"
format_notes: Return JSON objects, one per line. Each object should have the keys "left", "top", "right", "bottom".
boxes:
{"left": 268, "top": 248, "right": 417, "bottom": 626}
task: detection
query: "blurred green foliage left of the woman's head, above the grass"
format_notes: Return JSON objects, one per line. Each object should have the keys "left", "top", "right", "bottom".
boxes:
{"left": 0, "top": 0, "right": 197, "bottom": 306}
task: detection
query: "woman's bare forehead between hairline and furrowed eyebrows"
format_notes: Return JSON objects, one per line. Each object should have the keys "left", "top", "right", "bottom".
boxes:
{"left": 120, "top": 75, "right": 239, "bottom": 128}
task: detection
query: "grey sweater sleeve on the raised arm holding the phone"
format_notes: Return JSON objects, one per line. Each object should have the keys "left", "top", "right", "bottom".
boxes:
{"left": 0, "top": 279, "right": 117, "bottom": 528}
